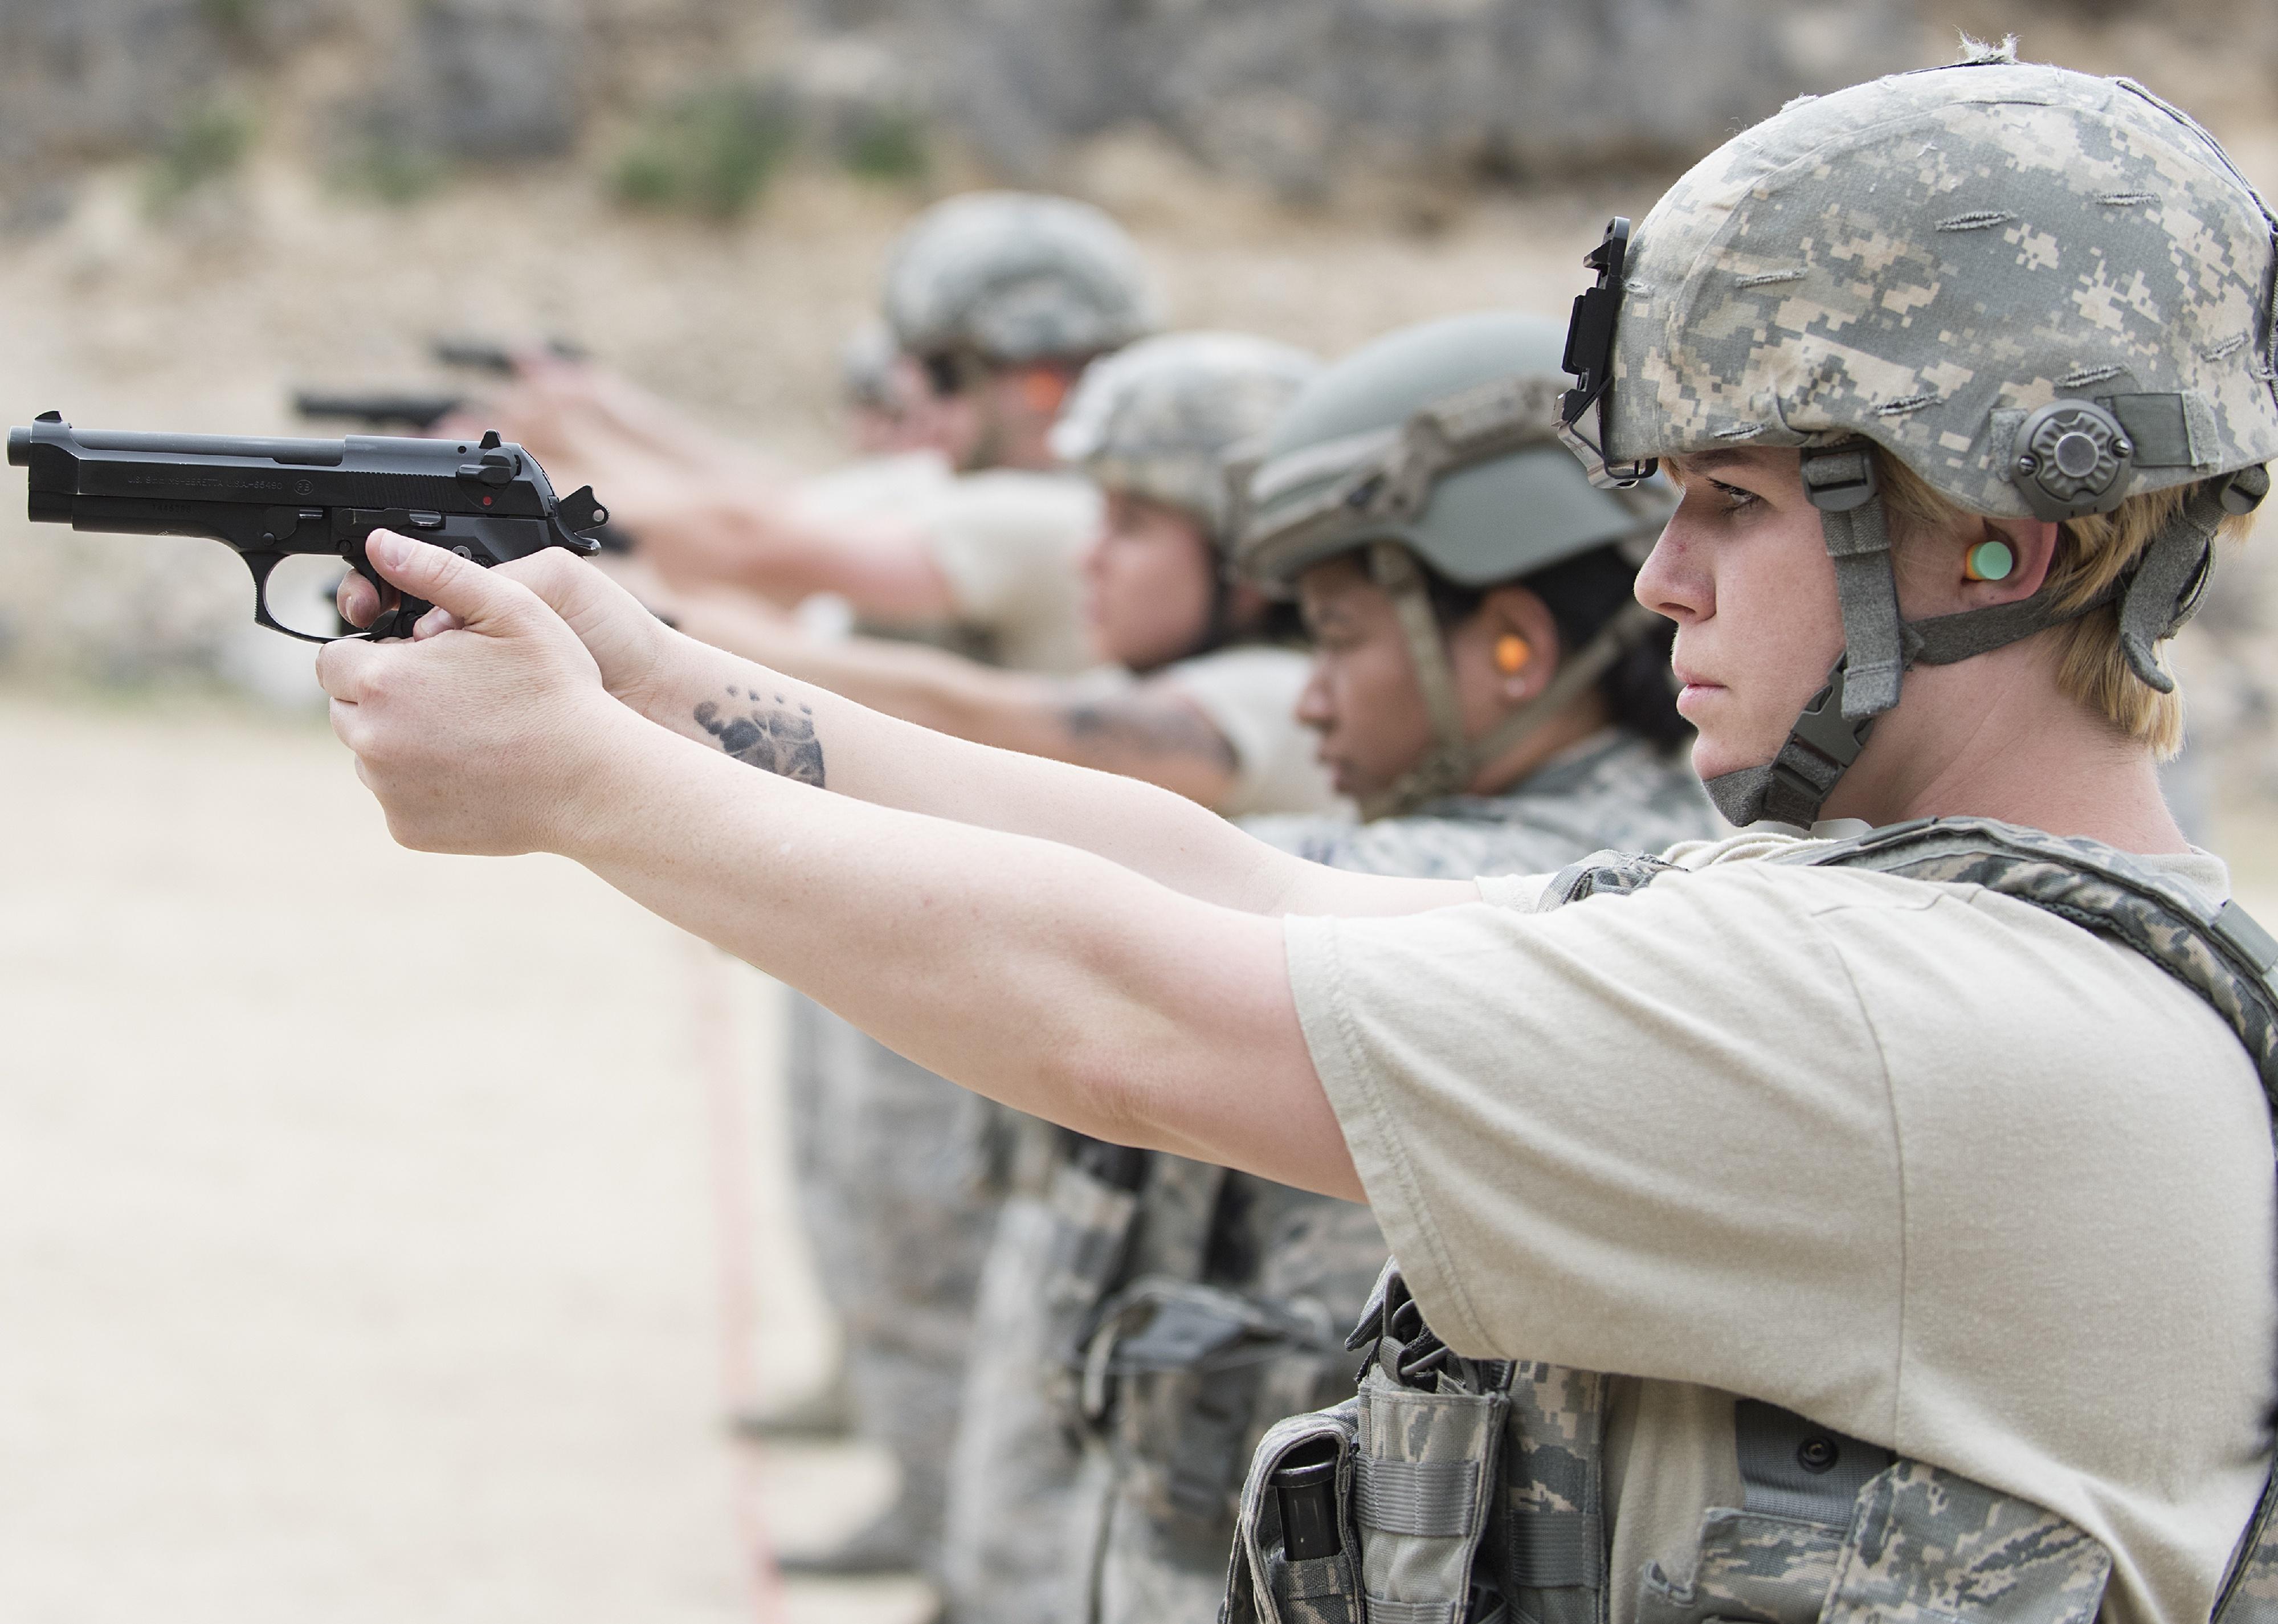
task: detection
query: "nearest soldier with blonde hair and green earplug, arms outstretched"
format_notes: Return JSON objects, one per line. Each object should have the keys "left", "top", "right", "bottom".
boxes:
{"left": 332, "top": 55, "right": 2278, "bottom": 1624}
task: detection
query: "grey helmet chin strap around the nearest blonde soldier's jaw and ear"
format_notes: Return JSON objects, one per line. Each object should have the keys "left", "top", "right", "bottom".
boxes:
{"left": 1707, "top": 439, "right": 2269, "bottom": 829}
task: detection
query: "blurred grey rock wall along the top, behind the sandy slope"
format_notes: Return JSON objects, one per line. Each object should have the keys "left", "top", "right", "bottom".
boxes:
{"left": 0, "top": 0, "right": 1920, "bottom": 198}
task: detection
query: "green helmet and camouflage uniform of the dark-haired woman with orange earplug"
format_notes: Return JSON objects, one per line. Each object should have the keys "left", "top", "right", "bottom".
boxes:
{"left": 950, "top": 312, "right": 1715, "bottom": 1624}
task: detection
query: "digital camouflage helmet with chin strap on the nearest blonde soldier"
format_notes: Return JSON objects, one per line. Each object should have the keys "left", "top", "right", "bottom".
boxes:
{"left": 1563, "top": 48, "right": 2278, "bottom": 825}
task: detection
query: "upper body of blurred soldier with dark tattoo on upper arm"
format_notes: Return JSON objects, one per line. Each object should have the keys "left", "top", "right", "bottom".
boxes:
{"left": 660, "top": 333, "right": 1337, "bottom": 815}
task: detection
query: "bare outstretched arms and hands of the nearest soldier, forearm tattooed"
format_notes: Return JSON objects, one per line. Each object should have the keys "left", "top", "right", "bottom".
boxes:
{"left": 319, "top": 540, "right": 1385, "bottom": 1196}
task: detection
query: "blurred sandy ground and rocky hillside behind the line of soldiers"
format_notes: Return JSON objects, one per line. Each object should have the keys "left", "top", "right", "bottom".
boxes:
{"left": 0, "top": 0, "right": 2278, "bottom": 1624}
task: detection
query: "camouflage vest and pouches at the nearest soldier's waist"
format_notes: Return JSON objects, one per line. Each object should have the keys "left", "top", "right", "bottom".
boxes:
{"left": 1223, "top": 1271, "right": 2112, "bottom": 1624}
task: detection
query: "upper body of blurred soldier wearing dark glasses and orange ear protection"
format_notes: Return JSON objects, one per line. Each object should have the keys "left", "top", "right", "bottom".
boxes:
{"left": 485, "top": 191, "right": 1157, "bottom": 672}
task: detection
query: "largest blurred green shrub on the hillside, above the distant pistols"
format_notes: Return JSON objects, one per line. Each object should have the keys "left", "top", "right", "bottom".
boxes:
{"left": 610, "top": 82, "right": 797, "bottom": 221}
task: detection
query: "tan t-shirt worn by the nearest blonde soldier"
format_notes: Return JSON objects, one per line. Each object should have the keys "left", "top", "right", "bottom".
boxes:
{"left": 1287, "top": 836, "right": 2278, "bottom": 1624}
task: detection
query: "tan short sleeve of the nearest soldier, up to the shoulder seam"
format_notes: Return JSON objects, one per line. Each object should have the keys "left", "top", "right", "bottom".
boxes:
{"left": 1287, "top": 870, "right": 1927, "bottom": 1398}
